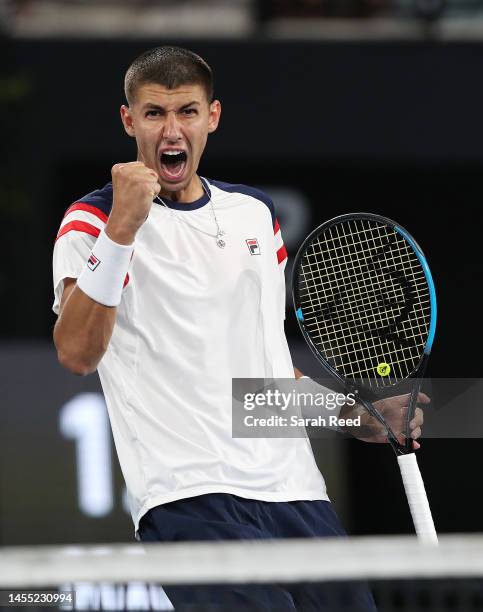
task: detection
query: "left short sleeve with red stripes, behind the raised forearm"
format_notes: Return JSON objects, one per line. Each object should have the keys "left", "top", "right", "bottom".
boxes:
{"left": 52, "top": 203, "right": 107, "bottom": 314}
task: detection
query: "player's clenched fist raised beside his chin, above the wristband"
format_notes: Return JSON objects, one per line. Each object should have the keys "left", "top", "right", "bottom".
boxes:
{"left": 106, "top": 161, "right": 161, "bottom": 244}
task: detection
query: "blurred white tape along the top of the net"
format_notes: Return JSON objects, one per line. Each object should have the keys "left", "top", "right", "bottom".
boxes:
{"left": 0, "top": 534, "right": 483, "bottom": 589}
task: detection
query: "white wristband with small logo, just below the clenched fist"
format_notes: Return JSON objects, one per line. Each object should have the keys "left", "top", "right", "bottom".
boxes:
{"left": 77, "top": 230, "right": 134, "bottom": 306}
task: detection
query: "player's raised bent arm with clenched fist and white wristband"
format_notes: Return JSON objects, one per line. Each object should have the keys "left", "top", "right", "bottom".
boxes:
{"left": 54, "top": 162, "right": 160, "bottom": 376}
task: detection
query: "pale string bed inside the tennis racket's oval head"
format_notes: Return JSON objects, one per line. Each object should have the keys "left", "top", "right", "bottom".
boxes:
{"left": 299, "top": 220, "right": 431, "bottom": 386}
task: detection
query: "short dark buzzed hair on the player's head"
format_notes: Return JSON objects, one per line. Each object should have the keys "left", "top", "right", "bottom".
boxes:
{"left": 124, "top": 46, "right": 214, "bottom": 104}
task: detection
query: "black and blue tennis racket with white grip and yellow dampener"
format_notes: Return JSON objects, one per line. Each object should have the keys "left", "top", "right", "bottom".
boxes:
{"left": 292, "top": 213, "right": 437, "bottom": 543}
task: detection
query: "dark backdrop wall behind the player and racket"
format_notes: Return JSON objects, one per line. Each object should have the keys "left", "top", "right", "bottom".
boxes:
{"left": 0, "top": 39, "right": 483, "bottom": 544}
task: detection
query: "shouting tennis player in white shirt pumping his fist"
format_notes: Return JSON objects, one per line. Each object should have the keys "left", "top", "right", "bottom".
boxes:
{"left": 53, "top": 47, "right": 426, "bottom": 611}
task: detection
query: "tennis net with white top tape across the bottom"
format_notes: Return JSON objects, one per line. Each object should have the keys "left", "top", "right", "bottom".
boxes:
{"left": 0, "top": 535, "right": 483, "bottom": 612}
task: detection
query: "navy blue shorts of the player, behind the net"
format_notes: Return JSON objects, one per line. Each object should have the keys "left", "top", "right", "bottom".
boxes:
{"left": 139, "top": 493, "right": 376, "bottom": 612}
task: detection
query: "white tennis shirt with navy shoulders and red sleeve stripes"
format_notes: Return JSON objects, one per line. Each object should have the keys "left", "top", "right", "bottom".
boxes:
{"left": 53, "top": 179, "right": 328, "bottom": 530}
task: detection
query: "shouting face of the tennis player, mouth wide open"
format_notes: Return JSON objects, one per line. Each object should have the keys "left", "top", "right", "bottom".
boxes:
{"left": 121, "top": 83, "right": 221, "bottom": 195}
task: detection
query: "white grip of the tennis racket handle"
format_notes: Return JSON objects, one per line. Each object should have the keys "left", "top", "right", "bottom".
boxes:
{"left": 397, "top": 453, "right": 438, "bottom": 544}
